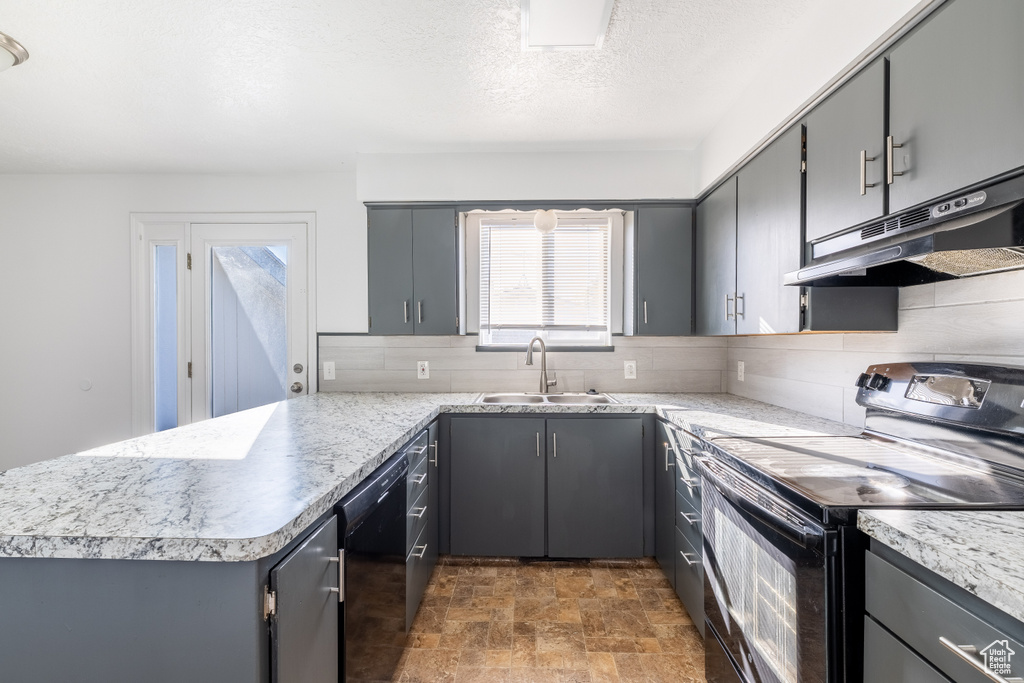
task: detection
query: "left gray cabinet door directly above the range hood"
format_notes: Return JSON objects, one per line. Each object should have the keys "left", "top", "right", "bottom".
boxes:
{"left": 806, "top": 59, "right": 886, "bottom": 242}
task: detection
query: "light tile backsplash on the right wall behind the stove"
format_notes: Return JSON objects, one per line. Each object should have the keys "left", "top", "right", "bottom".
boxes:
{"left": 726, "top": 270, "right": 1024, "bottom": 426}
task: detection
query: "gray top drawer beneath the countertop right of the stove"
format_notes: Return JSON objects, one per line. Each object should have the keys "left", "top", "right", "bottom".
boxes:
{"left": 864, "top": 552, "right": 1024, "bottom": 683}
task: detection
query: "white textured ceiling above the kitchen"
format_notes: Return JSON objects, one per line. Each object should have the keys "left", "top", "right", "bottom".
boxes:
{"left": 0, "top": 0, "right": 887, "bottom": 172}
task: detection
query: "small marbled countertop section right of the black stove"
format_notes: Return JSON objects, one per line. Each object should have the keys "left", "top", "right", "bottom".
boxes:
{"left": 857, "top": 510, "right": 1024, "bottom": 622}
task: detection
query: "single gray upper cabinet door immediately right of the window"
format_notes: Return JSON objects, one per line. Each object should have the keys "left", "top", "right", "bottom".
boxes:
{"left": 636, "top": 207, "right": 693, "bottom": 336}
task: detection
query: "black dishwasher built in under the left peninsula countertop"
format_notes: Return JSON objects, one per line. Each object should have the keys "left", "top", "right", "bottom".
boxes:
{"left": 335, "top": 452, "right": 409, "bottom": 681}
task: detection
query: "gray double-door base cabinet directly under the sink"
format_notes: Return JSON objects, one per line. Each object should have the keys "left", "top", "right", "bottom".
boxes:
{"left": 449, "top": 417, "right": 644, "bottom": 557}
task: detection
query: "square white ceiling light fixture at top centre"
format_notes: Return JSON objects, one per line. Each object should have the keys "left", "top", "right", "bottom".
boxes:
{"left": 520, "top": 0, "right": 614, "bottom": 50}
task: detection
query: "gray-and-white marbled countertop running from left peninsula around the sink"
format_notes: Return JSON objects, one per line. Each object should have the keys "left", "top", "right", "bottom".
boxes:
{"left": 0, "top": 393, "right": 856, "bottom": 562}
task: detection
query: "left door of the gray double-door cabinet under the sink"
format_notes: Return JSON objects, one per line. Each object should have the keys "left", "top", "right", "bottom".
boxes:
{"left": 451, "top": 417, "right": 545, "bottom": 557}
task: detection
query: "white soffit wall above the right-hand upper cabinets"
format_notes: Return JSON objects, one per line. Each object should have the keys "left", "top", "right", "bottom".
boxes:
{"left": 695, "top": 0, "right": 933, "bottom": 191}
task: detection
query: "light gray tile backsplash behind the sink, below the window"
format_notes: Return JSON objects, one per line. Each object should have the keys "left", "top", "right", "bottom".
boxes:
{"left": 317, "top": 334, "right": 727, "bottom": 393}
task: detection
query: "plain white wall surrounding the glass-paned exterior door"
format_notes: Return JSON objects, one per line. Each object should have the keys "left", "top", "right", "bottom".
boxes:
{"left": 0, "top": 173, "right": 367, "bottom": 470}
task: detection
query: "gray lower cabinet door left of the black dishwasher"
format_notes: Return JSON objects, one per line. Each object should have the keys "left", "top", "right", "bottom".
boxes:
{"left": 270, "top": 517, "right": 338, "bottom": 683}
